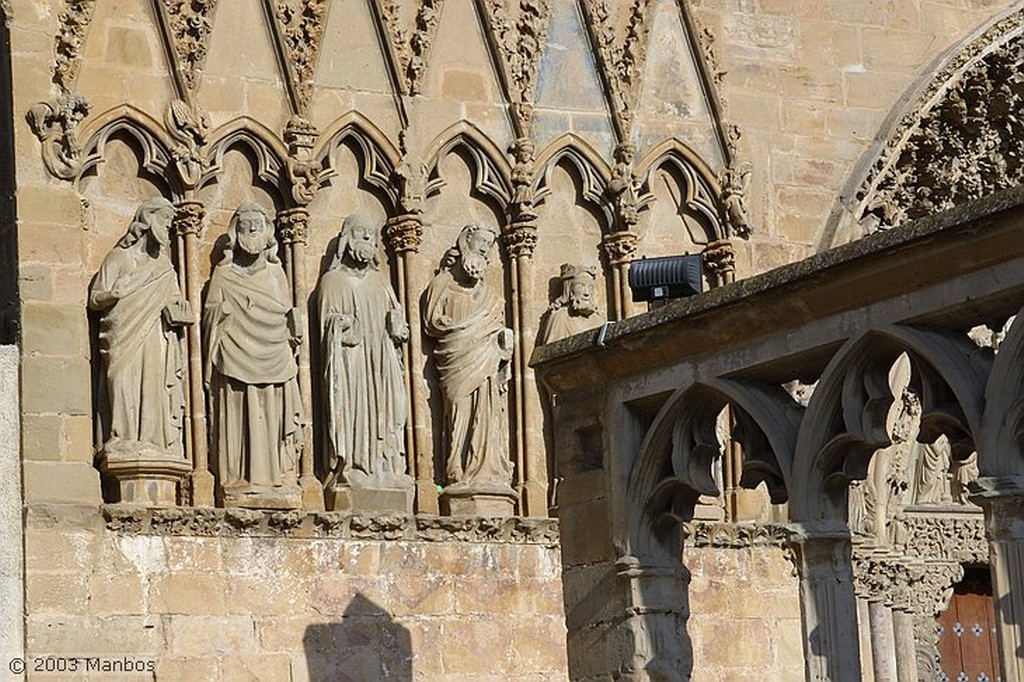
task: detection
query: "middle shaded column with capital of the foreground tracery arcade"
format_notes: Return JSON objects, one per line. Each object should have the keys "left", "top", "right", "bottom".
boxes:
{"left": 790, "top": 521, "right": 861, "bottom": 682}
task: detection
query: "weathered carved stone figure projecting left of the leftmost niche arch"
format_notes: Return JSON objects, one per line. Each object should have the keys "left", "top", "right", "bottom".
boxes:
{"left": 26, "top": 92, "right": 89, "bottom": 180}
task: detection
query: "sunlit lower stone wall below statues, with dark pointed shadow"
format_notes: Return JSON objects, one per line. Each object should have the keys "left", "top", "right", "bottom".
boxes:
{"left": 26, "top": 506, "right": 566, "bottom": 682}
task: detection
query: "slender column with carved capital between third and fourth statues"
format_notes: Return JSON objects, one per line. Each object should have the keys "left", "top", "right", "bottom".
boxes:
{"left": 384, "top": 213, "right": 439, "bottom": 514}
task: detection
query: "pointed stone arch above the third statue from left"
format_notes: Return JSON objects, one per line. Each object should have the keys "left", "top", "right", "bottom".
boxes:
{"left": 314, "top": 112, "right": 401, "bottom": 211}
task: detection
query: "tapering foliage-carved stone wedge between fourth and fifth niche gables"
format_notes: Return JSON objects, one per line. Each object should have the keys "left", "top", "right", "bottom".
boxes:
{"left": 483, "top": 0, "right": 551, "bottom": 133}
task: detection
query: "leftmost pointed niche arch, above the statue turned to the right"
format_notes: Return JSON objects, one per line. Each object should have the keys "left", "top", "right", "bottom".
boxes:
{"left": 76, "top": 104, "right": 177, "bottom": 200}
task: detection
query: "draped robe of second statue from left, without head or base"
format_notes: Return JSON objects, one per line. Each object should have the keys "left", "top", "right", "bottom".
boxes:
{"left": 203, "top": 262, "right": 302, "bottom": 489}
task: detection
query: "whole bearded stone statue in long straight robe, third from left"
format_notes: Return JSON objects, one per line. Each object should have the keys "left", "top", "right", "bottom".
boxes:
{"left": 317, "top": 214, "right": 413, "bottom": 512}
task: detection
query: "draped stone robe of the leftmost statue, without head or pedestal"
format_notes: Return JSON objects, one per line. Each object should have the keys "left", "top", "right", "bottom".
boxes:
{"left": 89, "top": 242, "right": 184, "bottom": 450}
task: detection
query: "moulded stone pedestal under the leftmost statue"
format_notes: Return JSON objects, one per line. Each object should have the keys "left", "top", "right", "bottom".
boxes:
{"left": 98, "top": 442, "right": 191, "bottom": 507}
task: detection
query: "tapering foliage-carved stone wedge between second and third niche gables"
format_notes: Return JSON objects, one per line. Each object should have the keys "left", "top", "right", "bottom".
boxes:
{"left": 274, "top": 0, "right": 327, "bottom": 112}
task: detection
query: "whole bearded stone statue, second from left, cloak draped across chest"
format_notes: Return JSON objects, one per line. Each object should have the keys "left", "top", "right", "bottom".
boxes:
{"left": 203, "top": 203, "right": 302, "bottom": 509}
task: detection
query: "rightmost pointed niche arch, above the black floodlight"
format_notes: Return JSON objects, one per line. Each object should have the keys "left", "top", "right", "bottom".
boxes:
{"left": 635, "top": 138, "right": 728, "bottom": 242}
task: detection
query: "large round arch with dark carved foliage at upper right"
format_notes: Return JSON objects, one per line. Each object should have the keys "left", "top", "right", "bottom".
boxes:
{"left": 817, "top": 3, "right": 1024, "bottom": 251}
